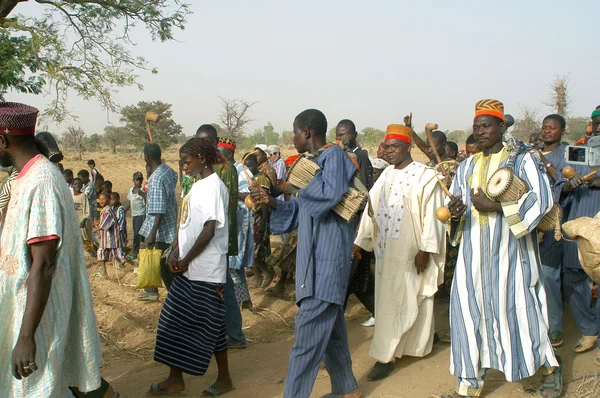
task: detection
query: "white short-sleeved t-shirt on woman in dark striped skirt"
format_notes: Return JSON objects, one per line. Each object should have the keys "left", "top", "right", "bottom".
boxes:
{"left": 179, "top": 173, "right": 229, "bottom": 283}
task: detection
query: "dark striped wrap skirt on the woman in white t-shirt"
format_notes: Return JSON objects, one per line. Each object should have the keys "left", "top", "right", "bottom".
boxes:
{"left": 154, "top": 275, "right": 227, "bottom": 376}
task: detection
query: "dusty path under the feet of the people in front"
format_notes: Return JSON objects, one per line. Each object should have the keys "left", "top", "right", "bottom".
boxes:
{"left": 103, "top": 288, "right": 600, "bottom": 398}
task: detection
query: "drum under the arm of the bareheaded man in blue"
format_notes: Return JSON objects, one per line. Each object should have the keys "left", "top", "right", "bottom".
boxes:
{"left": 285, "top": 155, "right": 369, "bottom": 222}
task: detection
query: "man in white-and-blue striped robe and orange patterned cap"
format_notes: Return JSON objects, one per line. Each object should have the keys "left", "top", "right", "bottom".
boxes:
{"left": 448, "top": 100, "right": 562, "bottom": 397}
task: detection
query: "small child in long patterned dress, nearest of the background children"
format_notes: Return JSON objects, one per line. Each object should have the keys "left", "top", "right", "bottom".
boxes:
{"left": 94, "top": 192, "right": 126, "bottom": 276}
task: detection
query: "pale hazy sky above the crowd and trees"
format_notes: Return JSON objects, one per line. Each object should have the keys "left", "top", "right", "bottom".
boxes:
{"left": 7, "top": 0, "right": 600, "bottom": 135}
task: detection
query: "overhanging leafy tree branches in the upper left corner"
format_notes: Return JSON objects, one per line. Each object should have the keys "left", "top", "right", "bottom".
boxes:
{"left": 0, "top": 0, "right": 190, "bottom": 122}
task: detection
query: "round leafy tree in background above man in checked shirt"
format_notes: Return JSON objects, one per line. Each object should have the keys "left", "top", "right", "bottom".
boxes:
{"left": 121, "top": 101, "right": 183, "bottom": 149}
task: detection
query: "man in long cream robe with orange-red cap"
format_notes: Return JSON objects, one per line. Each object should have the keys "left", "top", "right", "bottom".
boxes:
{"left": 354, "top": 125, "right": 446, "bottom": 381}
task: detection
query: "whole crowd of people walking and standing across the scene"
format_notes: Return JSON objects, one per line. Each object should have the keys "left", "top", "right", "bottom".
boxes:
{"left": 0, "top": 99, "right": 600, "bottom": 398}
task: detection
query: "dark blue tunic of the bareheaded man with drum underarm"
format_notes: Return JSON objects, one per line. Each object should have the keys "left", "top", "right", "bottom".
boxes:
{"left": 271, "top": 145, "right": 357, "bottom": 305}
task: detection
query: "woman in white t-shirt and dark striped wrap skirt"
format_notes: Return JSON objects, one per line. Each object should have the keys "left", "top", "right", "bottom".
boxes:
{"left": 150, "top": 138, "right": 233, "bottom": 396}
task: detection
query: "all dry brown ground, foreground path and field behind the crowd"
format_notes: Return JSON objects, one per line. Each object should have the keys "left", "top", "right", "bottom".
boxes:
{"left": 55, "top": 151, "right": 600, "bottom": 398}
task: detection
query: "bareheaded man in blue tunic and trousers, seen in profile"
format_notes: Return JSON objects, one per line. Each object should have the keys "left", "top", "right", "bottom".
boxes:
{"left": 251, "top": 109, "right": 360, "bottom": 398}
